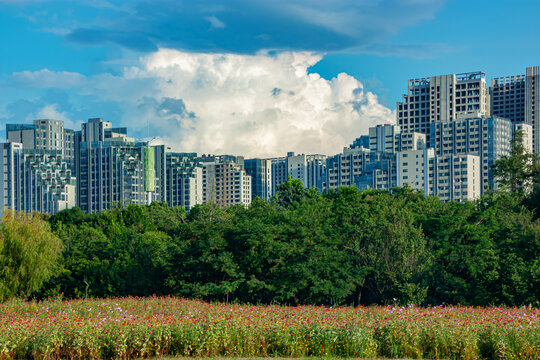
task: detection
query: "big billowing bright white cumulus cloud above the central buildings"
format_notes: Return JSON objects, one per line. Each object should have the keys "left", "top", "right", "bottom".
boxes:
{"left": 116, "top": 49, "right": 394, "bottom": 156}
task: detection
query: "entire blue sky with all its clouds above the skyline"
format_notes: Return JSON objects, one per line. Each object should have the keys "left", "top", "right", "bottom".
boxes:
{"left": 0, "top": 0, "right": 540, "bottom": 157}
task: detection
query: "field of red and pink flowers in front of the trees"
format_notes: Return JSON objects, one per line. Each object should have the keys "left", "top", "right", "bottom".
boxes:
{"left": 0, "top": 297, "right": 540, "bottom": 359}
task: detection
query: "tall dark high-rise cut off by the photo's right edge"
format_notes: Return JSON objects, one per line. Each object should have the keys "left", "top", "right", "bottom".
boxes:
{"left": 490, "top": 66, "right": 540, "bottom": 153}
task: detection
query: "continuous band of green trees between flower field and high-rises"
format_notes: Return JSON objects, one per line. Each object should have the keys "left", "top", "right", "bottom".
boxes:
{"left": 0, "top": 139, "right": 540, "bottom": 306}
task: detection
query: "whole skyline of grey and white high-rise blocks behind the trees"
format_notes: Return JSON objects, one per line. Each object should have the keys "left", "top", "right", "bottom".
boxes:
{"left": 0, "top": 66, "right": 540, "bottom": 214}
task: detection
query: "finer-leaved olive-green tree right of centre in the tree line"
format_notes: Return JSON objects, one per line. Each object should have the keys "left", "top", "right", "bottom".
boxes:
{"left": 328, "top": 187, "right": 427, "bottom": 304}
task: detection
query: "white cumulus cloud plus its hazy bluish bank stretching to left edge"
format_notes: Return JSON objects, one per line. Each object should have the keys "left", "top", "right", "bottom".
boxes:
{"left": 4, "top": 49, "right": 394, "bottom": 157}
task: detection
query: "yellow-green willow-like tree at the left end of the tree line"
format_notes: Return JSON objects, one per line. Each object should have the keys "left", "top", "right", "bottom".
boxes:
{"left": 0, "top": 210, "right": 62, "bottom": 301}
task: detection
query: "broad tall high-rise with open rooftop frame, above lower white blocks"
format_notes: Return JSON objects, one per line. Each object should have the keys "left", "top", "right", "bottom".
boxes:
{"left": 396, "top": 71, "right": 490, "bottom": 142}
